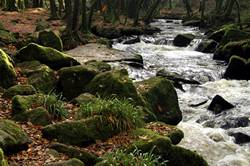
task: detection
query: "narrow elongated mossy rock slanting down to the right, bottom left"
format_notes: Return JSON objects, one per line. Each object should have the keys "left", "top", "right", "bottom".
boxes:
{"left": 50, "top": 143, "right": 97, "bottom": 166}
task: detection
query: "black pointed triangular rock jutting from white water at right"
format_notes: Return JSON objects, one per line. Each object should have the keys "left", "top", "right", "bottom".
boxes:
{"left": 208, "top": 95, "right": 234, "bottom": 114}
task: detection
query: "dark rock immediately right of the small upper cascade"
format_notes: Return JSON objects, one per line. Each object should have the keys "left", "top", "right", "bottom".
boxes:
{"left": 195, "top": 40, "right": 218, "bottom": 53}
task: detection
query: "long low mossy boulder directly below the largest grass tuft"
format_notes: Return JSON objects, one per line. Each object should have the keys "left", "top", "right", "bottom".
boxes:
{"left": 42, "top": 116, "right": 120, "bottom": 146}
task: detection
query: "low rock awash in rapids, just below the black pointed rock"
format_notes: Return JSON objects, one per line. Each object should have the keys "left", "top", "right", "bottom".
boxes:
{"left": 220, "top": 117, "right": 250, "bottom": 129}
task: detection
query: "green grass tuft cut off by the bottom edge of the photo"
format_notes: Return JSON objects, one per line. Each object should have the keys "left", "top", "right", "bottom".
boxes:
{"left": 96, "top": 149, "right": 167, "bottom": 166}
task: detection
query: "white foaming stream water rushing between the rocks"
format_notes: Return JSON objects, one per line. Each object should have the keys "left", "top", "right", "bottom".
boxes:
{"left": 113, "top": 20, "right": 250, "bottom": 166}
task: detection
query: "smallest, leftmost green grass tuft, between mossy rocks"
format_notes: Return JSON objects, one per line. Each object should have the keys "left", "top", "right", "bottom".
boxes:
{"left": 42, "top": 93, "right": 68, "bottom": 119}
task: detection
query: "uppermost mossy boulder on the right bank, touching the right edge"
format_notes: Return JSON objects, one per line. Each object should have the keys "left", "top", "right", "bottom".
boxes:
{"left": 208, "top": 24, "right": 250, "bottom": 46}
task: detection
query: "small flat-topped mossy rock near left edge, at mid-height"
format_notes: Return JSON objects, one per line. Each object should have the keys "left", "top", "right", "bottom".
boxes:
{"left": 3, "top": 85, "right": 36, "bottom": 98}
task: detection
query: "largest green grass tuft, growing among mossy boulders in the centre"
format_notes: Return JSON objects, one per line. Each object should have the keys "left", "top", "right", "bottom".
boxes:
{"left": 77, "top": 98, "right": 144, "bottom": 131}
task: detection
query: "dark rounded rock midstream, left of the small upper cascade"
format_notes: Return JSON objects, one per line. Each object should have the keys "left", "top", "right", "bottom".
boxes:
{"left": 173, "top": 34, "right": 195, "bottom": 47}
